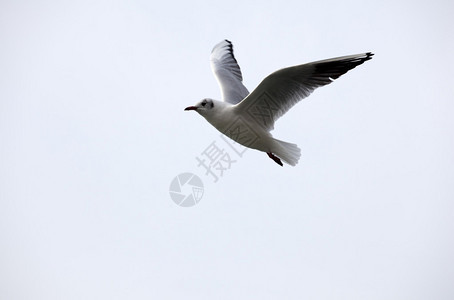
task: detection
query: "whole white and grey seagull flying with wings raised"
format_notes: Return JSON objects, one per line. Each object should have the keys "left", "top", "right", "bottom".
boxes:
{"left": 184, "top": 40, "right": 374, "bottom": 166}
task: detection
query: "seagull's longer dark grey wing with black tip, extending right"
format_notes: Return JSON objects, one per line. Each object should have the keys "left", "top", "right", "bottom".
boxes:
{"left": 235, "top": 52, "right": 373, "bottom": 130}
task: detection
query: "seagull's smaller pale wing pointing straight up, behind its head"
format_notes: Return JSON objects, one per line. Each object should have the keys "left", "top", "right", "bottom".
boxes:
{"left": 210, "top": 40, "right": 249, "bottom": 104}
